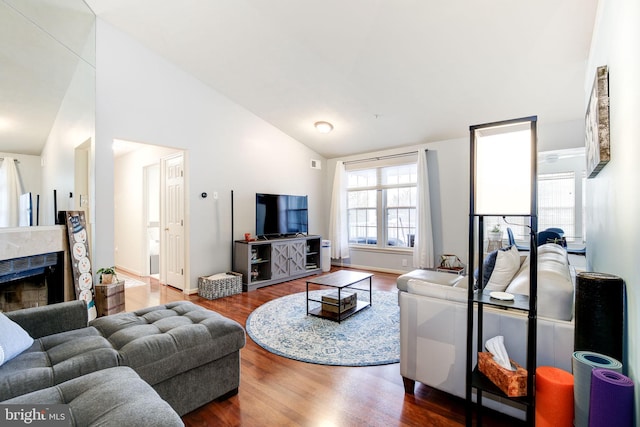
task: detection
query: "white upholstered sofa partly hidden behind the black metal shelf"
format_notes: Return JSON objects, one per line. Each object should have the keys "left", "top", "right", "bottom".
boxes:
{"left": 397, "top": 244, "right": 575, "bottom": 418}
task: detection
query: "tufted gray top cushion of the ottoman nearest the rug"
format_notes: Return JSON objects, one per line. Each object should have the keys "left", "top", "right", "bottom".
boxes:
{"left": 90, "top": 301, "right": 245, "bottom": 385}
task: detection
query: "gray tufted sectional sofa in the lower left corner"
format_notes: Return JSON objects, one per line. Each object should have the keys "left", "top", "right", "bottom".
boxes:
{"left": 0, "top": 301, "right": 245, "bottom": 426}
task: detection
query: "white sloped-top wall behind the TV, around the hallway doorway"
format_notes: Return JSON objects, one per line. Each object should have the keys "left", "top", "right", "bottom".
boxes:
{"left": 94, "top": 20, "right": 326, "bottom": 291}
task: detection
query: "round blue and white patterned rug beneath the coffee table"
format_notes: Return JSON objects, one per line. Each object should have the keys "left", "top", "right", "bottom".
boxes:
{"left": 246, "top": 290, "right": 400, "bottom": 366}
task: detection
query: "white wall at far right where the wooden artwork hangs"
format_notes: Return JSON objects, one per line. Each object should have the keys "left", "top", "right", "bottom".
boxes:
{"left": 585, "top": 0, "right": 640, "bottom": 416}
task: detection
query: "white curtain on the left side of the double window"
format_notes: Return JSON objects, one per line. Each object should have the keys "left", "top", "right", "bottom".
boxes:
{"left": 329, "top": 161, "right": 349, "bottom": 259}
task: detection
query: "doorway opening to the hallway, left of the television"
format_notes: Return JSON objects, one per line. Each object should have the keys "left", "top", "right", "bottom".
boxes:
{"left": 113, "top": 140, "right": 187, "bottom": 290}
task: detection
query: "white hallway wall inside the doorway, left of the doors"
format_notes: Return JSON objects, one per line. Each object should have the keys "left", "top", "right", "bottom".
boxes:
{"left": 113, "top": 144, "right": 176, "bottom": 275}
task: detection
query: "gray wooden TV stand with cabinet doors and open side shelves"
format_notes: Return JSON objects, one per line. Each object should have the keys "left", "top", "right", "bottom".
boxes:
{"left": 233, "top": 235, "right": 322, "bottom": 291}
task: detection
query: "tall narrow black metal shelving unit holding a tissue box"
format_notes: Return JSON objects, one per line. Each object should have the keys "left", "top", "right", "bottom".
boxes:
{"left": 466, "top": 116, "right": 538, "bottom": 426}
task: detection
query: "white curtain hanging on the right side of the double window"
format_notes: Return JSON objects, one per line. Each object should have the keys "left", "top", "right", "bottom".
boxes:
{"left": 413, "top": 150, "right": 434, "bottom": 268}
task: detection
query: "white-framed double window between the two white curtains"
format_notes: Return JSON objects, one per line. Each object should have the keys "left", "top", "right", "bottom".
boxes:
{"left": 347, "top": 162, "right": 417, "bottom": 248}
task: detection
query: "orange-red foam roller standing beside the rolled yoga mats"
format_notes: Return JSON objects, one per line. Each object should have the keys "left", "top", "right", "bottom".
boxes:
{"left": 536, "top": 366, "right": 573, "bottom": 427}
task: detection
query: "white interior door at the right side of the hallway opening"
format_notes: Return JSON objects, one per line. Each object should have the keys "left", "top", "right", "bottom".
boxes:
{"left": 164, "top": 154, "right": 185, "bottom": 290}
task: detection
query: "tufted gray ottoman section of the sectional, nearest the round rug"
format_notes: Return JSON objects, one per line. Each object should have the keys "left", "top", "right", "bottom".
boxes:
{"left": 90, "top": 301, "right": 245, "bottom": 415}
